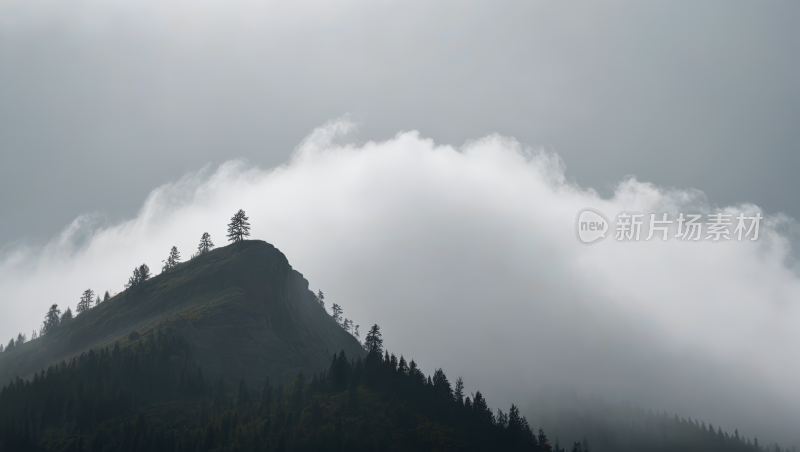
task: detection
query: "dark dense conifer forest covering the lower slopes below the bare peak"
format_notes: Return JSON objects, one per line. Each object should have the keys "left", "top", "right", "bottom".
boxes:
{"left": 0, "top": 326, "right": 568, "bottom": 452}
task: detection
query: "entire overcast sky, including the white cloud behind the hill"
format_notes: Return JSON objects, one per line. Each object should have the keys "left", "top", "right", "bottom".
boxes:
{"left": 0, "top": 0, "right": 800, "bottom": 444}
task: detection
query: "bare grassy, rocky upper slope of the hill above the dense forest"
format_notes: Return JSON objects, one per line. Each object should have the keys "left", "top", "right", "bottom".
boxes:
{"left": 0, "top": 240, "right": 361, "bottom": 385}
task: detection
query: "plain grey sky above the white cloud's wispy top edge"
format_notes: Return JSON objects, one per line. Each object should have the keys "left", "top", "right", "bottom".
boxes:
{"left": 0, "top": 0, "right": 800, "bottom": 242}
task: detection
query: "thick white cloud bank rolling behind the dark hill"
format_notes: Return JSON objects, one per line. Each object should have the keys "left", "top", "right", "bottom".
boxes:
{"left": 0, "top": 120, "right": 800, "bottom": 441}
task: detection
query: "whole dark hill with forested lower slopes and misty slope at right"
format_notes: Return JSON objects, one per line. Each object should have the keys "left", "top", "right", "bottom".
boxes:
{"left": 0, "top": 241, "right": 784, "bottom": 452}
